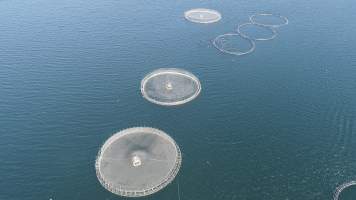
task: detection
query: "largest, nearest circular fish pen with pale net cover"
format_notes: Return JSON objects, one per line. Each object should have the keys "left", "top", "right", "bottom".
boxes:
{"left": 95, "top": 127, "right": 182, "bottom": 197}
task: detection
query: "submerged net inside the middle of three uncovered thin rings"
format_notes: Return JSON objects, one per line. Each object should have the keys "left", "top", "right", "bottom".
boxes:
{"left": 237, "top": 23, "right": 277, "bottom": 41}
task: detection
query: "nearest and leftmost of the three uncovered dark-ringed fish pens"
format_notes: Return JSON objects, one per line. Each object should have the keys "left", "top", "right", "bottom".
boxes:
{"left": 213, "top": 33, "right": 256, "bottom": 56}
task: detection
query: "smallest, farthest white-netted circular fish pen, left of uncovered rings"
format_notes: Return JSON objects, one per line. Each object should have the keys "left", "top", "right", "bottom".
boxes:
{"left": 184, "top": 8, "right": 221, "bottom": 24}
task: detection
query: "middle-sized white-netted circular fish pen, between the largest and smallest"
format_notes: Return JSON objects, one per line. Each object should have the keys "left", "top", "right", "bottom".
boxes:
{"left": 141, "top": 68, "right": 201, "bottom": 106}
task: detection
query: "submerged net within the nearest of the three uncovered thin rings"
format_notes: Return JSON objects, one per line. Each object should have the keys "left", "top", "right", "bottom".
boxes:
{"left": 213, "top": 33, "right": 256, "bottom": 56}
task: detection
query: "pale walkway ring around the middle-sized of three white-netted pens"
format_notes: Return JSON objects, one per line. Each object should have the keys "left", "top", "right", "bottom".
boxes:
{"left": 141, "top": 68, "right": 201, "bottom": 106}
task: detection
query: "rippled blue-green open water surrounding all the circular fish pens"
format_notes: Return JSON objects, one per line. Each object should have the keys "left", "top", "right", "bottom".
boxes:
{"left": 0, "top": 0, "right": 356, "bottom": 200}
